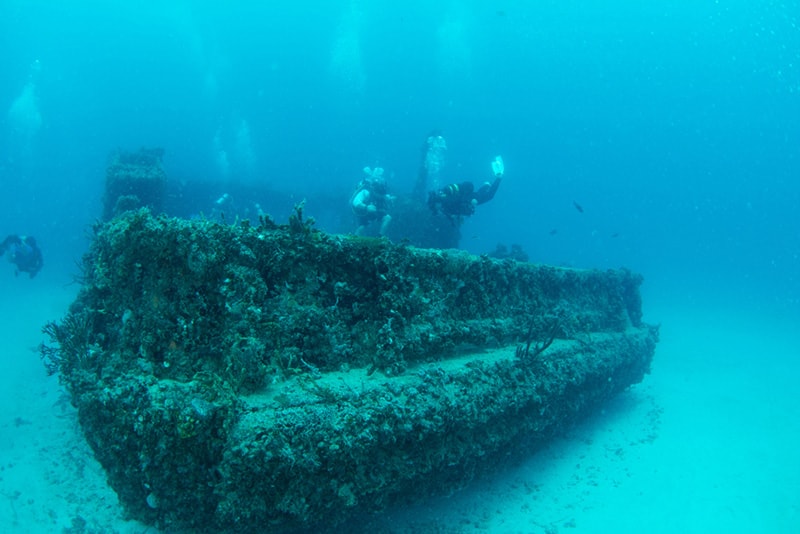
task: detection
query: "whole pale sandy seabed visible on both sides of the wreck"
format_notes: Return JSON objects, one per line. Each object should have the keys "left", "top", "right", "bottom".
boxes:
{"left": 0, "top": 273, "right": 800, "bottom": 534}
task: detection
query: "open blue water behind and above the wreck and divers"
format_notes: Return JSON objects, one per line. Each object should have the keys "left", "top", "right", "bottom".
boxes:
{"left": 0, "top": 0, "right": 800, "bottom": 532}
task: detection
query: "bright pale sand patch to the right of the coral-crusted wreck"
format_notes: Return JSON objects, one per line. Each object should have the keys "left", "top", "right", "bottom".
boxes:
{"left": 372, "top": 303, "right": 800, "bottom": 533}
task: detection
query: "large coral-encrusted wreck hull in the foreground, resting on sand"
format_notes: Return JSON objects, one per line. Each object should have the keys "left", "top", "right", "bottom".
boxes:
{"left": 41, "top": 208, "right": 658, "bottom": 532}
